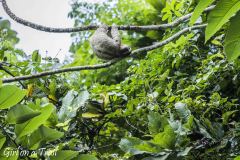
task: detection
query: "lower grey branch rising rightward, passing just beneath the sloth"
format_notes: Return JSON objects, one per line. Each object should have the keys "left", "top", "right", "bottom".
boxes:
{"left": 2, "top": 24, "right": 206, "bottom": 83}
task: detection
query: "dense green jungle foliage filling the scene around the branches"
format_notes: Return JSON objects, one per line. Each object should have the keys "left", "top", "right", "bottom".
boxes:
{"left": 0, "top": 0, "right": 240, "bottom": 160}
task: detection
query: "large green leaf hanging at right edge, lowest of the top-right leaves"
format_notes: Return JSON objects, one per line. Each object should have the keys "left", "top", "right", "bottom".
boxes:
{"left": 224, "top": 12, "right": 240, "bottom": 60}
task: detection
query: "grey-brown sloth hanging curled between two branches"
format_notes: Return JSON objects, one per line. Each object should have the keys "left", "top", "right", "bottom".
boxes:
{"left": 90, "top": 24, "right": 131, "bottom": 60}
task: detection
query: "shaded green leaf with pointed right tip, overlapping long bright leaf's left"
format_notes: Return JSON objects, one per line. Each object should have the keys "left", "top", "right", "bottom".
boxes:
{"left": 7, "top": 105, "right": 41, "bottom": 124}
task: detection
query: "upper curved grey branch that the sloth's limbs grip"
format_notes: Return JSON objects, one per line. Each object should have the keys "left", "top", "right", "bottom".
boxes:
{"left": 2, "top": 0, "right": 215, "bottom": 33}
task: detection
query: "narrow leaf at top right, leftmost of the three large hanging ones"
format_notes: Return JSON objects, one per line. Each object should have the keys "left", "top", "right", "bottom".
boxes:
{"left": 189, "top": 0, "right": 215, "bottom": 25}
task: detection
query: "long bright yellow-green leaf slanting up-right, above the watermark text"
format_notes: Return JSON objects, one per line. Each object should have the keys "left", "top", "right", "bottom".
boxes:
{"left": 15, "top": 104, "right": 53, "bottom": 138}
